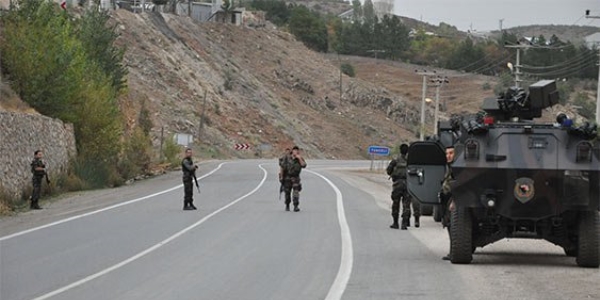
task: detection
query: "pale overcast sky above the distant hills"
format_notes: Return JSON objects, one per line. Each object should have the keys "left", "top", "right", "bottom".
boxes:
{"left": 392, "top": 0, "right": 600, "bottom": 31}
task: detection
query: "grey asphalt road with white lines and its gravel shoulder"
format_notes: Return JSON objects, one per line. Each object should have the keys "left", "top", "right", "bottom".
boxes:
{"left": 0, "top": 160, "right": 600, "bottom": 300}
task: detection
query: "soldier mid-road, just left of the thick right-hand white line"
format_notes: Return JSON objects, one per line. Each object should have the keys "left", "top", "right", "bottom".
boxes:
{"left": 280, "top": 146, "right": 306, "bottom": 211}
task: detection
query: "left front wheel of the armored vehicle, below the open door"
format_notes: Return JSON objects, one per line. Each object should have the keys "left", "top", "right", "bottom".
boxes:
{"left": 450, "top": 208, "right": 473, "bottom": 264}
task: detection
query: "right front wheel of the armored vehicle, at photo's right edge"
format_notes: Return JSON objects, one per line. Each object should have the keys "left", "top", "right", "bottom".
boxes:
{"left": 576, "top": 211, "right": 600, "bottom": 268}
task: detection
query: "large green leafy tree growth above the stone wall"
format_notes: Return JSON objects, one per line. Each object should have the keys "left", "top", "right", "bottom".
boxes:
{"left": 0, "top": 0, "right": 126, "bottom": 185}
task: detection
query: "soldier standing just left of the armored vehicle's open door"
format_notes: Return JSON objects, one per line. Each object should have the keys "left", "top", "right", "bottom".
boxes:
{"left": 386, "top": 144, "right": 421, "bottom": 230}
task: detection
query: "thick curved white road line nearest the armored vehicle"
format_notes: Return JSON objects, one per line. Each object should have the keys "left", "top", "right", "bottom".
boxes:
{"left": 306, "top": 170, "right": 354, "bottom": 300}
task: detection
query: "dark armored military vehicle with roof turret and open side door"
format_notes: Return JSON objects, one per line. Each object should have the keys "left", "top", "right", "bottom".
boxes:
{"left": 407, "top": 80, "right": 600, "bottom": 268}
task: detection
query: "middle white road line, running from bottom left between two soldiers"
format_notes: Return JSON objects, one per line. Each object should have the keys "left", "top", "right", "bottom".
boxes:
{"left": 33, "top": 165, "right": 267, "bottom": 300}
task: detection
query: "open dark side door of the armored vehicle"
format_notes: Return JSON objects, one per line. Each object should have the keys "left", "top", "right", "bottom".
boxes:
{"left": 406, "top": 141, "right": 446, "bottom": 204}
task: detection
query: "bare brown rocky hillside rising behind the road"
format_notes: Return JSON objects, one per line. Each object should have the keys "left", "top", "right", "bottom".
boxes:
{"left": 114, "top": 10, "right": 420, "bottom": 158}
